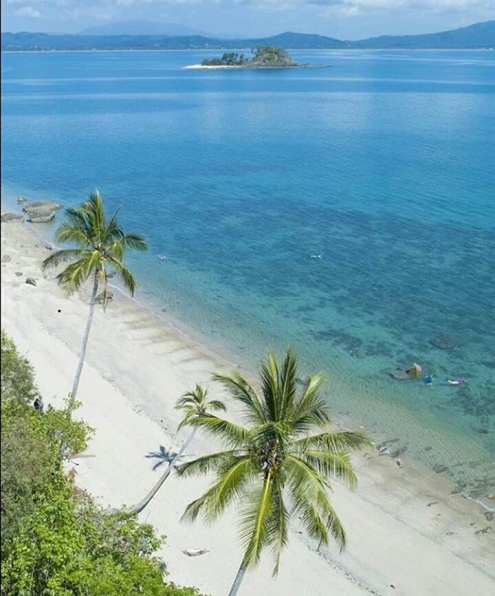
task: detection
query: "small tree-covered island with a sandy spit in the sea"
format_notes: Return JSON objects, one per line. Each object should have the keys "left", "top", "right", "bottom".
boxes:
{"left": 186, "top": 45, "right": 313, "bottom": 69}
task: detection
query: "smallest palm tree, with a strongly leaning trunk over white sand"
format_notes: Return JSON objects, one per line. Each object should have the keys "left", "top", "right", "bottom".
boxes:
{"left": 133, "top": 383, "right": 225, "bottom": 513}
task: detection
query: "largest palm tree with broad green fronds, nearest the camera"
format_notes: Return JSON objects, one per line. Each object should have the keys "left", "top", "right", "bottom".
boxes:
{"left": 177, "top": 350, "right": 370, "bottom": 596}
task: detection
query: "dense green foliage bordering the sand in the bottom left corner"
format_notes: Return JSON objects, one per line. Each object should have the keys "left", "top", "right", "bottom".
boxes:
{"left": 1, "top": 332, "right": 202, "bottom": 596}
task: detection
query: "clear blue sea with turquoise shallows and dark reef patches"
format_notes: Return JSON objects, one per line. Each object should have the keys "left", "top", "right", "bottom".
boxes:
{"left": 1, "top": 50, "right": 495, "bottom": 507}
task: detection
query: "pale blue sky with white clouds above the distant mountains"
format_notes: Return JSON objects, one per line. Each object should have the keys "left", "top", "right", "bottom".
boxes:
{"left": 1, "top": 0, "right": 495, "bottom": 40}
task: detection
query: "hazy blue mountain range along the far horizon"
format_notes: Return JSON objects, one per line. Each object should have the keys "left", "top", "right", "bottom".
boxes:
{"left": 1, "top": 21, "right": 495, "bottom": 51}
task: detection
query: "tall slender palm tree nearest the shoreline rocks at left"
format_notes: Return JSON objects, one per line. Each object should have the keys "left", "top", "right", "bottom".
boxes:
{"left": 42, "top": 191, "right": 148, "bottom": 408}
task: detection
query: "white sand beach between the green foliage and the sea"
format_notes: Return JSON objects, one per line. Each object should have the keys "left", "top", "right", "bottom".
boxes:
{"left": 1, "top": 223, "right": 495, "bottom": 596}
